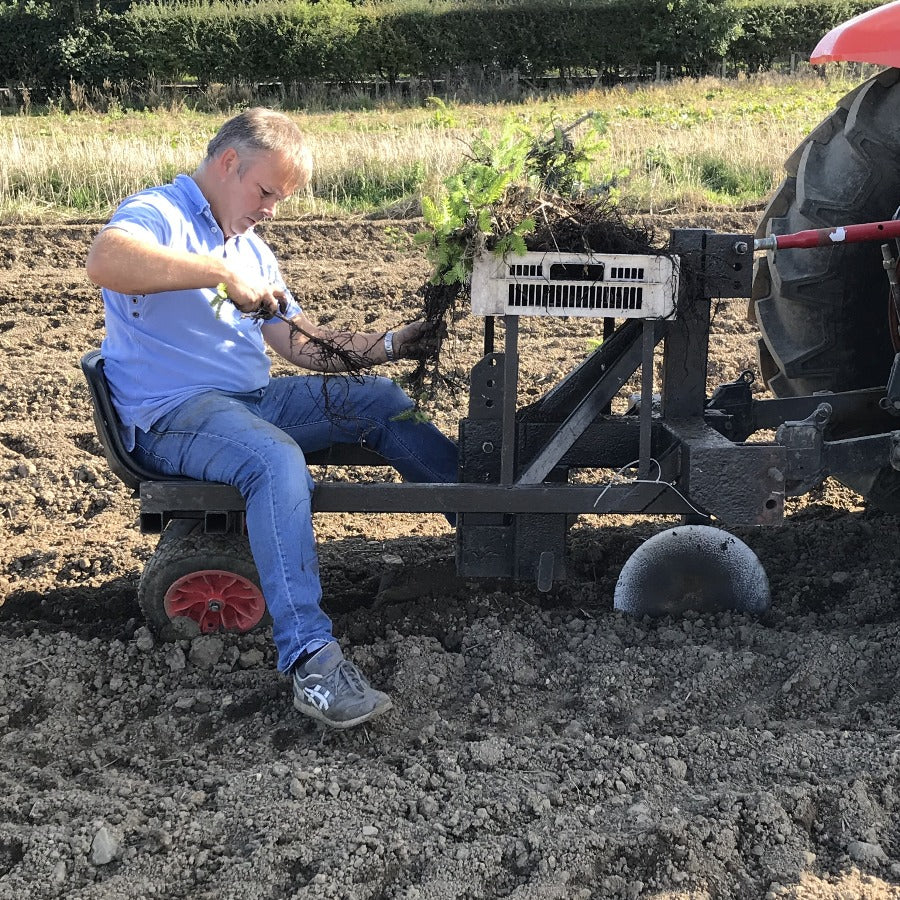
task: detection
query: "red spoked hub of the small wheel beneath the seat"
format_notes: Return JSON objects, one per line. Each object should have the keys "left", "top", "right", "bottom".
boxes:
{"left": 164, "top": 569, "right": 266, "bottom": 634}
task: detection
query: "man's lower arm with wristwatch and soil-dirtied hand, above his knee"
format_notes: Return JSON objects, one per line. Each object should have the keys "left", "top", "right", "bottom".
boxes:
{"left": 263, "top": 313, "right": 425, "bottom": 372}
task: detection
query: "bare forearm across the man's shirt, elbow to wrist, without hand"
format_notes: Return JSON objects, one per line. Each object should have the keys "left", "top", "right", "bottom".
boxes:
{"left": 85, "top": 228, "right": 228, "bottom": 294}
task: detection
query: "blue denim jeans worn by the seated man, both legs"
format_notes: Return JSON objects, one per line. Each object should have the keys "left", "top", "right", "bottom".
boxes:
{"left": 134, "top": 375, "right": 457, "bottom": 671}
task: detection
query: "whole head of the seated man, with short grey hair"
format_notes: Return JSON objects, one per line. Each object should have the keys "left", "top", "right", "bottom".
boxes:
{"left": 194, "top": 107, "right": 312, "bottom": 237}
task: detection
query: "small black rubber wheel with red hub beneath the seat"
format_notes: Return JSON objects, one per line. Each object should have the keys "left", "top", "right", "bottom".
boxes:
{"left": 138, "top": 521, "right": 271, "bottom": 640}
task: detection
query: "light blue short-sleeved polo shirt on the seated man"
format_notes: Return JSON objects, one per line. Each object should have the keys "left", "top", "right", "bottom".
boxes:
{"left": 102, "top": 175, "right": 300, "bottom": 450}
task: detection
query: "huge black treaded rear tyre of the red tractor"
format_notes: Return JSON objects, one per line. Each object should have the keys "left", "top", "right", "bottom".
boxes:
{"left": 750, "top": 69, "right": 900, "bottom": 512}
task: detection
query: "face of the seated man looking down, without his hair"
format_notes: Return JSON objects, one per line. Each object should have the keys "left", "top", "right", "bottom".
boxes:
{"left": 210, "top": 148, "right": 302, "bottom": 237}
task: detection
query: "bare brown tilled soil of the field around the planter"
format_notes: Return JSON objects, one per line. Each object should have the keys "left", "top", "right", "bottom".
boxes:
{"left": 0, "top": 217, "right": 900, "bottom": 900}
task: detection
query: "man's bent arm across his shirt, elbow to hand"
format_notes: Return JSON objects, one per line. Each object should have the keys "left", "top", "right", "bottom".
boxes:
{"left": 85, "top": 228, "right": 284, "bottom": 314}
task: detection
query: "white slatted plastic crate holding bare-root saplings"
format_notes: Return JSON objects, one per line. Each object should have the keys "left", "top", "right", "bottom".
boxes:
{"left": 472, "top": 252, "right": 678, "bottom": 319}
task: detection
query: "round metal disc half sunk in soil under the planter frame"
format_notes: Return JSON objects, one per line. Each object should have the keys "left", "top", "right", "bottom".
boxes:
{"left": 613, "top": 525, "right": 771, "bottom": 616}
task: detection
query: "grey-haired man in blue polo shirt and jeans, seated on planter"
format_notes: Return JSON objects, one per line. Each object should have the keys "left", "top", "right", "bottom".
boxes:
{"left": 87, "top": 108, "right": 457, "bottom": 728}
